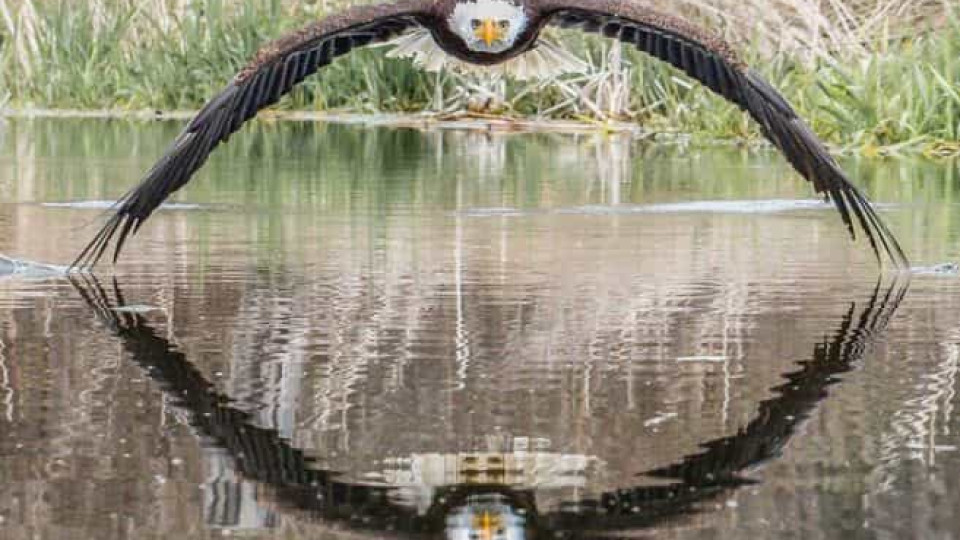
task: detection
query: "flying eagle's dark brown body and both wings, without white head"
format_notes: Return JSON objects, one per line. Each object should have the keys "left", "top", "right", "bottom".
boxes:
{"left": 72, "top": 0, "right": 908, "bottom": 268}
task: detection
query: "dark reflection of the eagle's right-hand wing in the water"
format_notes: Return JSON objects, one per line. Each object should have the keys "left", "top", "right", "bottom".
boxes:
{"left": 542, "top": 275, "right": 910, "bottom": 536}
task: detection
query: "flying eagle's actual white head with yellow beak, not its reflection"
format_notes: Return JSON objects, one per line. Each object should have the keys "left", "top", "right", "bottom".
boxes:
{"left": 447, "top": 0, "right": 527, "bottom": 53}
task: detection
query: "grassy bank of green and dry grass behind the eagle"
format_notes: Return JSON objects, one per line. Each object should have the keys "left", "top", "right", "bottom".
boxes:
{"left": 0, "top": 0, "right": 960, "bottom": 154}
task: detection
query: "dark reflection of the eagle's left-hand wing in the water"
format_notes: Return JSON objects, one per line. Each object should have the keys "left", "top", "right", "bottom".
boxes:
{"left": 69, "top": 276, "right": 419, "bottom": 531}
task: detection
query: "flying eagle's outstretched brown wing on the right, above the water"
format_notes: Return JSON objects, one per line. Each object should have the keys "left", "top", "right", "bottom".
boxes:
{"left": 540, "top": 0, "right": 909, "bottom": 268}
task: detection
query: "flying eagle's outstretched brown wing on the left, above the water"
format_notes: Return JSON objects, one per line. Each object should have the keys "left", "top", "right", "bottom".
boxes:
{"left": 71, "top": 0, "right": 430, "bottom": 268}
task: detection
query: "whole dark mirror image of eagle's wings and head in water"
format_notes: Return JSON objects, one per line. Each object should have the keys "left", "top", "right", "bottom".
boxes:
{"left": 71, "top": 275, "right": 908, "bottom": 540}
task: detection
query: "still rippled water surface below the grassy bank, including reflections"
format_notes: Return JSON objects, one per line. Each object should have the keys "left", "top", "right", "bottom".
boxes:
{"left": 0, "top": 120, "right": 960, "bottom": 540}
